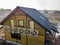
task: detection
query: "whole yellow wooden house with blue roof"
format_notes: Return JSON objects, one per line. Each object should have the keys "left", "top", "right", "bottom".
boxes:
{"left": 0, "top": 6, "right": 57, "bottom": 45}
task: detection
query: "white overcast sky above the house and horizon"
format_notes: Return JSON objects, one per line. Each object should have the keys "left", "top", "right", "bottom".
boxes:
{"left": 0, "top": 0, "right": 60, "bottom": 10}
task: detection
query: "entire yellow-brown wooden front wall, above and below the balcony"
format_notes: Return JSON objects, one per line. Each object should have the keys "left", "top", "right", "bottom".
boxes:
{"left": 3, "top": 10, "right": 45, "bottom": 45}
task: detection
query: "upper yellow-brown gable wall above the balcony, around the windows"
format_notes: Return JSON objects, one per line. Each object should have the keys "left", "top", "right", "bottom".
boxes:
{"left": 4, "top": 6, "right": 45, "bottom": 35}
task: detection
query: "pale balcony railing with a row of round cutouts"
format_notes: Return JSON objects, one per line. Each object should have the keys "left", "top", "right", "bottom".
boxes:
{"left": 4, "top": 26, "right": 38, "bottom": 37}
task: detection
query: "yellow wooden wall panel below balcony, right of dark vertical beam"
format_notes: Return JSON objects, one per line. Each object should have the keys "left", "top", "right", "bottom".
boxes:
{"left": 28, "top": 36, "right": 45, "bottom": 45}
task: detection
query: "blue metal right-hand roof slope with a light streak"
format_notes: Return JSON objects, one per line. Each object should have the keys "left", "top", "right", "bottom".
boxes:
{"left": 19, "top": 7, "right": 51, "bottom": 31}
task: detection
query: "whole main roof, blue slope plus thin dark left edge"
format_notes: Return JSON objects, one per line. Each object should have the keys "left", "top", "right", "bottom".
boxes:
{"left": 1, "top": 6, "right": 51, "bottom": 31}
